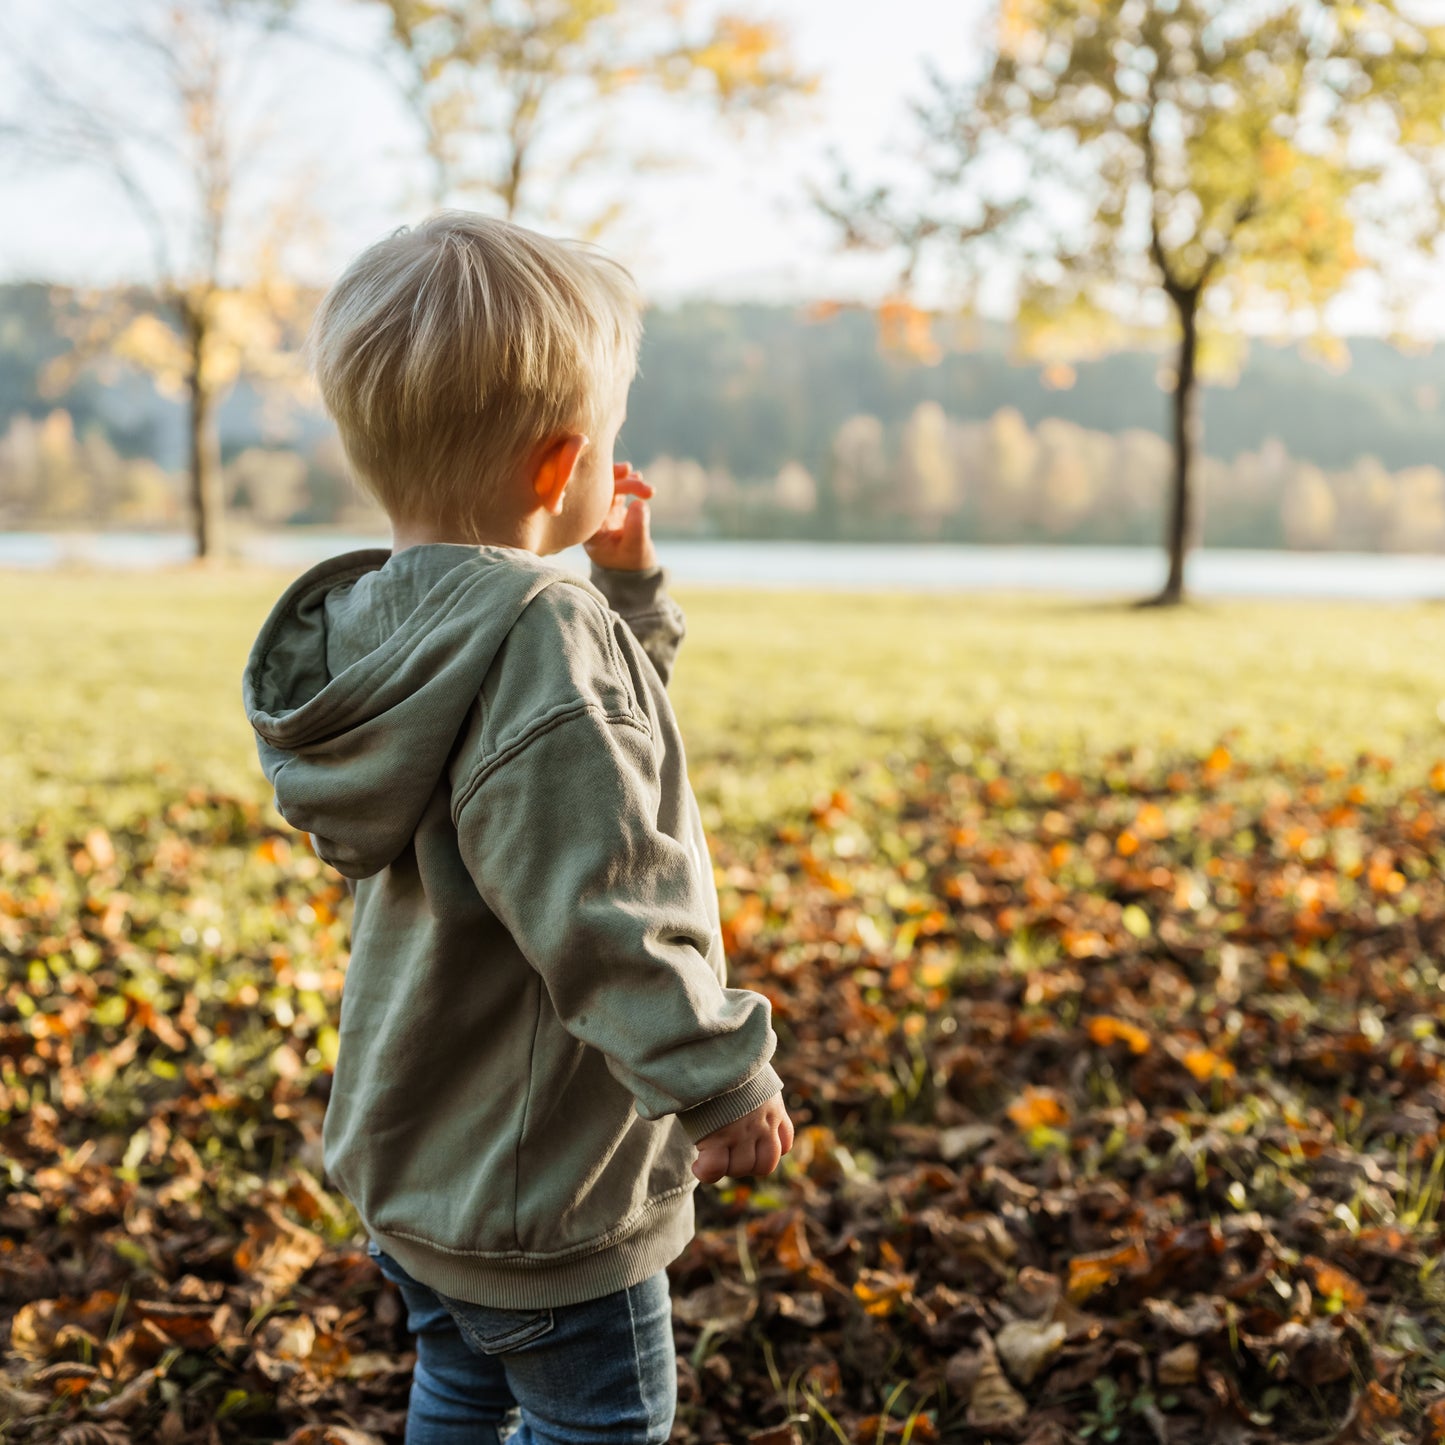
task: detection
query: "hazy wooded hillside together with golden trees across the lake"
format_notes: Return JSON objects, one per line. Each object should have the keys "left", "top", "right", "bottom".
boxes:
{"left": 0, "top": 286, "right": 1445, "bottom": 551}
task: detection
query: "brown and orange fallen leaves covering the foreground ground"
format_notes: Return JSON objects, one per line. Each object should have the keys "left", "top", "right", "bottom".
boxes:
{"left": 8, "top": 737, "right": 1445, "bottom": 1445}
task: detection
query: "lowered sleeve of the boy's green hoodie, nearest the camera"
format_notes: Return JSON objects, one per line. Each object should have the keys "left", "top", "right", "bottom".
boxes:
{"left": 454, "top": 578, "right": 782, "bottom": 1140}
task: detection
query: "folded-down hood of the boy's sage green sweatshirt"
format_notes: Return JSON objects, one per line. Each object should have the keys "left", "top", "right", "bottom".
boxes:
{"left": 243, "top": 543, "right": 569, "bottom": 879}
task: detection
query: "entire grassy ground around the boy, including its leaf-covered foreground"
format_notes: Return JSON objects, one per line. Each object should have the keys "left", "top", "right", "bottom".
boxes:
{"left": 8, "top": 572, "right": 1445, "bottom": 1445}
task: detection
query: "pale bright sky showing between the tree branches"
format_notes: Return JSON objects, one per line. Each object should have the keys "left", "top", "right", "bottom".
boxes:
{"left": 8, "top": 0, "right": 1445, "bottom": 335}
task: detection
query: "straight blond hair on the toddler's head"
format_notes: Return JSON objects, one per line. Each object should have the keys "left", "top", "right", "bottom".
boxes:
{"left": 309, "top": 211, "right": 642, "bottom": 533}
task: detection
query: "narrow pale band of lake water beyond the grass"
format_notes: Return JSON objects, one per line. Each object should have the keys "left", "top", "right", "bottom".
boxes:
{"left": 0, "top": 532, "right": 1445, "bottom": 601}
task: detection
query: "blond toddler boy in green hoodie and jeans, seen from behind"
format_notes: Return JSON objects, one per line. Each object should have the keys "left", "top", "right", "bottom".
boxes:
{"left": 244, "top": 212, "right": 793, "bottom": 1445}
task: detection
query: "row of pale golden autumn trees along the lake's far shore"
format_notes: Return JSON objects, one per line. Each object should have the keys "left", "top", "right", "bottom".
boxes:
{"left": 0, "top": 402, "right": 1445, "bottom": 552}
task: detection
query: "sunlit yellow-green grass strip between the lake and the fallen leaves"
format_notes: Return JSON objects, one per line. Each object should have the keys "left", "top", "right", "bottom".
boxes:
{"left": 0, "top": 571, "right": 1445, "bottom": 827}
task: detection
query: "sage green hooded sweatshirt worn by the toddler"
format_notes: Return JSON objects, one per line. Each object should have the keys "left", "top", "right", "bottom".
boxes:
{"left": 244, "top": 543, "right": 780, "bottom": 1309}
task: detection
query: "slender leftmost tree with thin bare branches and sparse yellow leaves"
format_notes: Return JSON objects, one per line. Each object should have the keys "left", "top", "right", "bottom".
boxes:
{"left": 0, "top": 0, "right": 319, "bottom": 558}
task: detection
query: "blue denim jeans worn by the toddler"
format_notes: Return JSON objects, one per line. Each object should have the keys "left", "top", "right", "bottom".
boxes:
{"left": 368, "top": 1243, "right": 678, "bottom": 1445}
